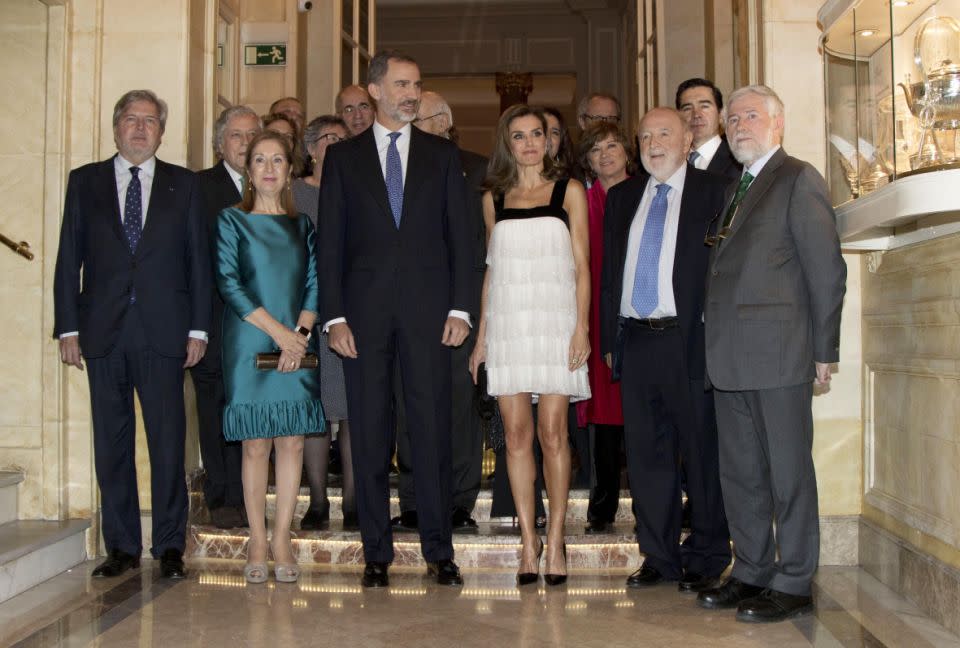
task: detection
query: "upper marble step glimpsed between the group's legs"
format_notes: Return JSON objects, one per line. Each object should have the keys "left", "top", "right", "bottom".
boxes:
{"left": 190, "top": 486, "right": 633, "bottom": 525}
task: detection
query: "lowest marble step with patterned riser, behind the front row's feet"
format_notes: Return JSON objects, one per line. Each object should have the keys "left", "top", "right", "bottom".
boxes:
{"left": 185, "top": 522, "right": 640, "bottom": 573}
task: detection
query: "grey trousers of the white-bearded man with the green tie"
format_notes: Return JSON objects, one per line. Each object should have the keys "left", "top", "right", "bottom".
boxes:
{"left": 714, "top": 383, "right": 820, "bottom": 596}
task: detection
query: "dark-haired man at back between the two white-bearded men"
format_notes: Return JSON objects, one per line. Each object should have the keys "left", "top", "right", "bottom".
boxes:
{"left": 676, "top": 79, "right": 742, "bottom": 181}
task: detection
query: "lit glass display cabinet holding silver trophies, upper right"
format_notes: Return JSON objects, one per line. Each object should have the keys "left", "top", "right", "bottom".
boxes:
{"left": 819, "top": 0, "right": 960, "bottom": 248}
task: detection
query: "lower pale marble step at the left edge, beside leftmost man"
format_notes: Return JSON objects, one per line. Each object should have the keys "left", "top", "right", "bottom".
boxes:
{"left": 0, "top": 520, "right": 90, "bottom": 602}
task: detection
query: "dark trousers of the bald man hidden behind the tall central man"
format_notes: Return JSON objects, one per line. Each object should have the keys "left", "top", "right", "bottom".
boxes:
{"left": 394, "top": 328, "right": 483, "bottom": 511}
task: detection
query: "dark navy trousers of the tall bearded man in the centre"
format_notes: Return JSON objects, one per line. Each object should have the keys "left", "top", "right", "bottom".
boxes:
{"left": 343, "top": 311, "right": 453, "bottom": 563}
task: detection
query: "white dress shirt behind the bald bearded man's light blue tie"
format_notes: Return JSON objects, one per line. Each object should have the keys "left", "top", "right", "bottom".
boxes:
{"left": 620, "top": 164, "right": 687, "bottom": 319}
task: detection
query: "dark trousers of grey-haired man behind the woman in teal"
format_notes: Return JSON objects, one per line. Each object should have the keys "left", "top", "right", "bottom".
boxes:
{"left": 190, "top": 298, "right": 243, "bottom": 510}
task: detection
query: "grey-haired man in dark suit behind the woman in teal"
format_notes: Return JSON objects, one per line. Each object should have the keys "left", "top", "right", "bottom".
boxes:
{"left": 190, "top": 106, "right": 260, "bottom": 529}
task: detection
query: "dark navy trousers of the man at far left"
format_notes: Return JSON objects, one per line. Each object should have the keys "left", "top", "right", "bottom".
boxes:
{"left": 87, "top": 306, "right": 187, "bottom": 558}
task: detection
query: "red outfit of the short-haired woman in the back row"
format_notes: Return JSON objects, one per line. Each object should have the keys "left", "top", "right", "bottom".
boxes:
{"left": 576, "top": 182, "right": 623, "bottom": 427}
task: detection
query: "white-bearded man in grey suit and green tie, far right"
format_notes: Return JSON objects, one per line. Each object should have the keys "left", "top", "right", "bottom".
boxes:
{"left": 699, "top": 86, "right": 847, "bottom": 622}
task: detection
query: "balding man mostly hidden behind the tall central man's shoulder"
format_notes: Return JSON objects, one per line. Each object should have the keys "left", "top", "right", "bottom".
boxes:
{"left": 393, "top": 92, "right": 487, "bottom": 533}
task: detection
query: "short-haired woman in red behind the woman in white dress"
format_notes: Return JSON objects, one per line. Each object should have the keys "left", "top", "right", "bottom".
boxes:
{"left": 576, "top": 122, "right": 634, "bottom": 533}
